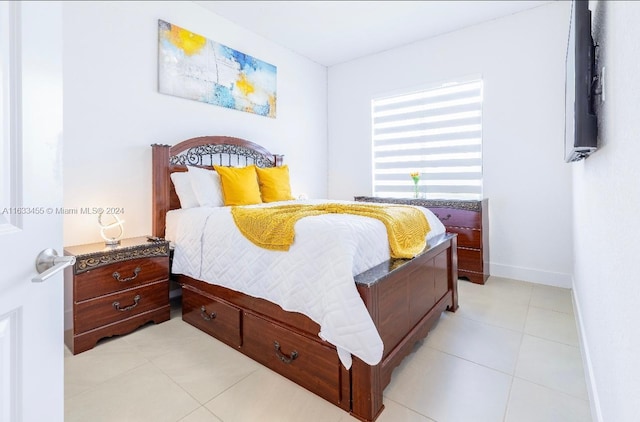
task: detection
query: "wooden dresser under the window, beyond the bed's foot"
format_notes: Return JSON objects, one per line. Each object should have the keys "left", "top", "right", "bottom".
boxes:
{"left": 354, "top": 196, "right": 489, "bottom": 284}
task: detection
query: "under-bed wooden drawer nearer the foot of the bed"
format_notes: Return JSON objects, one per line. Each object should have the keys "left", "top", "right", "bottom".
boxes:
{"left": 242, "top": 312, "right": 340, "bottom": 403}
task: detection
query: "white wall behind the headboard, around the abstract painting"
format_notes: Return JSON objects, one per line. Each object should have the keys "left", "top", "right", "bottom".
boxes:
{"left": 62, "top": 1, "right": 327, "bottom": 245}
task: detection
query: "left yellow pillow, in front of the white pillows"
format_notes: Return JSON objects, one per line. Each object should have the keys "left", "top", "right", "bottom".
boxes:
{"left": 213, "top": 165, "right": 262, "bottom": 205}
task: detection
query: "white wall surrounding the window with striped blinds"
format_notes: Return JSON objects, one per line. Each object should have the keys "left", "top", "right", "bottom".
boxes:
{"left": 329, "top": 2, "right": 572, "bottom": 287}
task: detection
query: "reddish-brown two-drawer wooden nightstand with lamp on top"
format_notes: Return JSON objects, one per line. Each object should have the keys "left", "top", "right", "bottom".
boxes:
{"left": 64, "top": 236, "right": 171, "bottom": 355}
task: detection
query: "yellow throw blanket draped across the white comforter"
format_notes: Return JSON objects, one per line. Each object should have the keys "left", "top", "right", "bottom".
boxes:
{"left": 231, "top": 203, "right": 430, "bottom": 258}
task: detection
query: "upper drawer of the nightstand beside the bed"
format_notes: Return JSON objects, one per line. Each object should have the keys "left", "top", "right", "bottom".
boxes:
{"left": 74, "top": 257, "right": 169, "bottom": 302}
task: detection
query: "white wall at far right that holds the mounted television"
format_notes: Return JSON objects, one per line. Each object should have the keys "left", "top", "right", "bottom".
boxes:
{"left": 572, "top": 1, "right": 640, "bottom": 421}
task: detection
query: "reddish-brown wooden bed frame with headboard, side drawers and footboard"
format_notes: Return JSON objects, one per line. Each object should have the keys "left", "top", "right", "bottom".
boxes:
{"left": 152, "top": 136, "right": 458, "bottom": 421}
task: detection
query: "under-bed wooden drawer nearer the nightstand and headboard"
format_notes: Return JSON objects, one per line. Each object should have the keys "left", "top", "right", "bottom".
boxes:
{"left": 182, "top": 286, "right": 242, "bottom": 348}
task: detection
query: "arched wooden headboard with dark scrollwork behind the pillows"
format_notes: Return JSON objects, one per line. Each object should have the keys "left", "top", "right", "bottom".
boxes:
{"left": 151, "top": 136, "right": 283, "bottom": 237}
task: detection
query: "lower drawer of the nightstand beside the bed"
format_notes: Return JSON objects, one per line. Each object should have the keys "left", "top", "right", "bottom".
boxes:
{"left": 74, "top": 281, "right": 169, "bottom": 334}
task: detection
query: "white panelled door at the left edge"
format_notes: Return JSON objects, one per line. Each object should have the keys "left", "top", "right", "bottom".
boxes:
{"left": 0, "top": 1, "right": 64, "bottom": 422}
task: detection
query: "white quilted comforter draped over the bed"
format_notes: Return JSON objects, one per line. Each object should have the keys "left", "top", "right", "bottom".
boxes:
{"left": 167, "top": 201, "right": 445, "bottom": 369}
